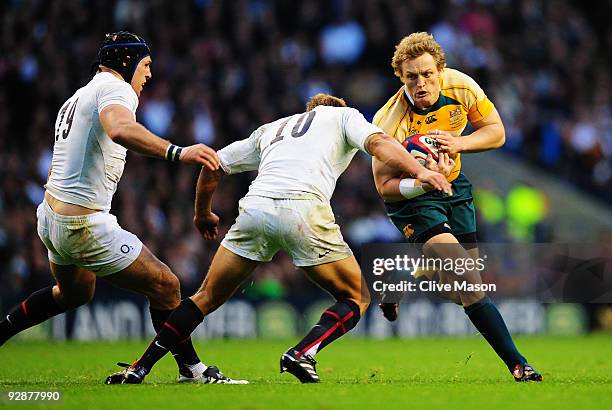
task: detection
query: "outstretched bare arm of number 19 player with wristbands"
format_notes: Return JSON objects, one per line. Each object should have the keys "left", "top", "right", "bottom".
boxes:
{"left": 100, "top": 104, "right": 219, "bottom": 170}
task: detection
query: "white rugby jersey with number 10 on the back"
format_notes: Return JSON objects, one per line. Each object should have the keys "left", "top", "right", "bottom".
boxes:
{"left": 218, "top": 106, "right": 382, "bottom": 201}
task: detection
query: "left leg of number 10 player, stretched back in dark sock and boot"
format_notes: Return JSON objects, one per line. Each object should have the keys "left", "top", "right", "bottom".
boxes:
{"left": 107, "top": 246, "right": 259, "bottom": 384}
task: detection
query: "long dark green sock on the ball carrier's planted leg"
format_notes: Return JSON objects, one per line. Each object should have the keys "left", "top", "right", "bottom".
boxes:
{"left": 465, "top": 296, "right": 527, "bottom": 371}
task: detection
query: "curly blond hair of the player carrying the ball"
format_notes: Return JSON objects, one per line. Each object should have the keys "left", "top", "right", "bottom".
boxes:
{"left": 391, "top": 31, "right": 446, "bottom": 78}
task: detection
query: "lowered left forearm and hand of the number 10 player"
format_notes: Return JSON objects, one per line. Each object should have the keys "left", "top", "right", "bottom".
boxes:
{"left": 193, "top": 167, "right": 223, "bottom": 240}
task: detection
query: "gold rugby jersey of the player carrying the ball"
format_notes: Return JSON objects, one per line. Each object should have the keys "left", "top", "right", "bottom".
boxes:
{"left": 373, "top": 68, "right": 494, "bottom": 181}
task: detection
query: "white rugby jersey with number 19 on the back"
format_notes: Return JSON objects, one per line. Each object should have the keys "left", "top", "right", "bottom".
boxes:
{"left": 45, "top": 72, "right": 138, "bottom": 211}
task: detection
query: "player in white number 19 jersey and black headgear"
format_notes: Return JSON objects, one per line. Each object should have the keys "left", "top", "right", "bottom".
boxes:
{"left": 0, "top": 32, "right": 245, "bottom": 382}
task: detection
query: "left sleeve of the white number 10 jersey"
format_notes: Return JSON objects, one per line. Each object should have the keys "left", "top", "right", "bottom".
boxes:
{"left": 217, "top": 127, "right": 263, "bottom": 175}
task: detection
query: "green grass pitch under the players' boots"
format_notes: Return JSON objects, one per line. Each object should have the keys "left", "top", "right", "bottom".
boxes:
{"left": 0, "top": 334, "right": 612, "bottom": 410}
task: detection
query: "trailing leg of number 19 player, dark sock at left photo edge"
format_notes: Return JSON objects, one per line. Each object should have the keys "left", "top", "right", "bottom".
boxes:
{"left": 0, "top": 262, "right": 96, "bottom": 346}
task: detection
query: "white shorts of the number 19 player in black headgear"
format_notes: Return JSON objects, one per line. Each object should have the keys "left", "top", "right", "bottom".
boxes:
{"left": 36, "top": 201, "right": 142, "bottom": 276}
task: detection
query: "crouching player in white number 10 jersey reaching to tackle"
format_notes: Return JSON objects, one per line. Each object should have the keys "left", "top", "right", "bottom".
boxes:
{"left": 106, "top": 94, "right": 454, "bottom": 384}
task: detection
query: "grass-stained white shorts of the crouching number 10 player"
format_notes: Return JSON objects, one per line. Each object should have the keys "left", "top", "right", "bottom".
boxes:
{"left": 221, "top": 196, "right": 353, "bottom": 266}
